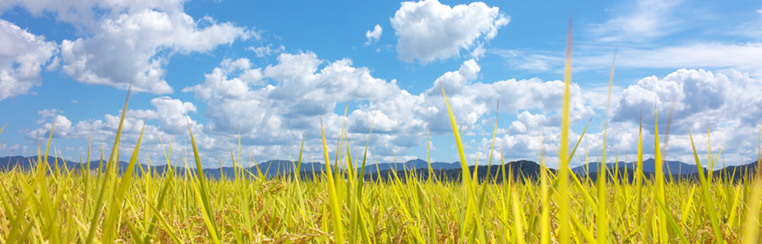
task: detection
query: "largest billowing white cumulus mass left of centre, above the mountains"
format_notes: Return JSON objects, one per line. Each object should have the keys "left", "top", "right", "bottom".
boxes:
{"left": 178, "top": 52, "right": 425, "bottom": 159}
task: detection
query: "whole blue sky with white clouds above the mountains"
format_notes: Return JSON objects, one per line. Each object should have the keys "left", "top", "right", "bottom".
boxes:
{"left": 0, "top": 0, "right": 762, "bottom": 167}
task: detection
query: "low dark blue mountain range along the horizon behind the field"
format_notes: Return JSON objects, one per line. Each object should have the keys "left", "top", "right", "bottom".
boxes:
{"left": 0, "top": 156, "right": 757, "bottom": 181}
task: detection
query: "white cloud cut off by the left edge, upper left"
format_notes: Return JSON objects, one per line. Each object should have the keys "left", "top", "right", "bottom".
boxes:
{"left": 0, "top": 19, "right": 58, "bottom": 101}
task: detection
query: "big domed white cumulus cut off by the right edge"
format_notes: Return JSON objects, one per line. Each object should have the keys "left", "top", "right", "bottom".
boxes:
{"left": 612, "top": 69, "right": 762, "bottom": 163}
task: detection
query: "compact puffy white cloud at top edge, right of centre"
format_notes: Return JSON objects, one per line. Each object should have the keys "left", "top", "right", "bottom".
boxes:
{"left": 391, "top": 0, "right": 509, "bottom": 63}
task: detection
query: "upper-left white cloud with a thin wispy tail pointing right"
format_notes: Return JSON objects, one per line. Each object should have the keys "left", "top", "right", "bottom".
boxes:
{"left": 61, "top": 9, "right": 249, "bottom": 94}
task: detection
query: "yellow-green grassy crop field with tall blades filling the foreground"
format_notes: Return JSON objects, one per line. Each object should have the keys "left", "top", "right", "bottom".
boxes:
{"left": 0, "top": 27, "right": 762, "bottom": 243}
